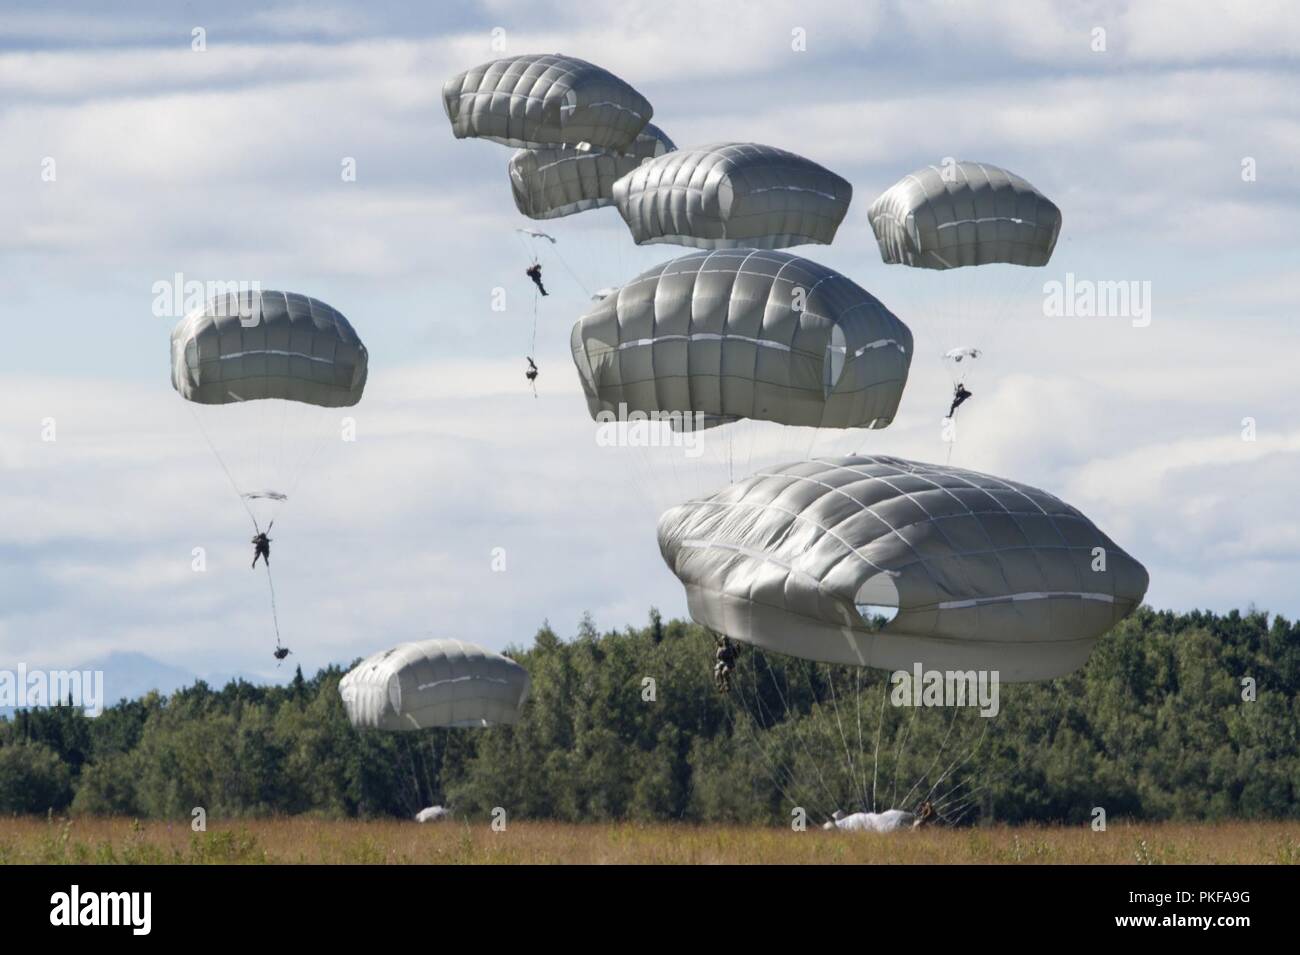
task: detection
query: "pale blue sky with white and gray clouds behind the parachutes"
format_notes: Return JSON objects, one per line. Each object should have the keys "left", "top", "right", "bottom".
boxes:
{"left": 0, "top": 0, "right": 1300, "bottom": 680}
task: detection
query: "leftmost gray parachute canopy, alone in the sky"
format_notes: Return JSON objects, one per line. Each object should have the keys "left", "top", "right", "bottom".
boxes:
{"left": 172, "top": 291, "right": 368, "bottom": 408}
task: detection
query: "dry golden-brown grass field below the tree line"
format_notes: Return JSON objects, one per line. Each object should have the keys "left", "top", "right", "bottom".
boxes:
{"left": 0, "top": 817, "right": 1300, "bottom": 865}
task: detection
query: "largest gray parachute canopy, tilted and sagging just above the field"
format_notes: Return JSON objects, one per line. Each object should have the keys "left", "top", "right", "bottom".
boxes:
{"left": 659, "top": 457, "right": 1148, "bottom": 682}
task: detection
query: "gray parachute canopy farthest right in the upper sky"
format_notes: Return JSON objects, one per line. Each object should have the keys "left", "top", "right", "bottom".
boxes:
{"left": 867, "top": 162, "right": 1061, "bottom": 269}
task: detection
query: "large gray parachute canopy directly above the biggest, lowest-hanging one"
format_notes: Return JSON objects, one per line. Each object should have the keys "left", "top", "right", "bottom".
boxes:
{"left": 571, "top": 249, "right": 913, "bottom": 427}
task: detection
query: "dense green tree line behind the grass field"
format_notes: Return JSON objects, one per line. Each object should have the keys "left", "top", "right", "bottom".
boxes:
{"left": 0, "top": 607, "right": 1300, "bottom": 824}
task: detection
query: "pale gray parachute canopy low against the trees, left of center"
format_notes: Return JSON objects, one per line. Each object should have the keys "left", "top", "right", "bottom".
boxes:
{"left": 338, "top": 639, "right": 528, "bottom": 730}
